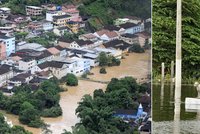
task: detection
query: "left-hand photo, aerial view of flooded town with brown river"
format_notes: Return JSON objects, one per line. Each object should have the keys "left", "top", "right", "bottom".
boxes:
{"left": 0, "top": 0, "right": 151, "bottom": 134}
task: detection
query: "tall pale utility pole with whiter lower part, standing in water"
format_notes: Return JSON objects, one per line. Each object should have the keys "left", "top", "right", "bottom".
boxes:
{"left": 175, "top": 0, "right": 182, "bottom": 101}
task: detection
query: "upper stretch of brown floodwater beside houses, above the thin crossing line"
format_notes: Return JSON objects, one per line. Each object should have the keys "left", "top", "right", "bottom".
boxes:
{"left": 89, "top": 52, "right": 151, "bottom": 81}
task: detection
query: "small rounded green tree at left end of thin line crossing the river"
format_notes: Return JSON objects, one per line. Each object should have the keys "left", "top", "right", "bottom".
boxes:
{"left": 60, "top": 73, "right": 78, "bottom": 86}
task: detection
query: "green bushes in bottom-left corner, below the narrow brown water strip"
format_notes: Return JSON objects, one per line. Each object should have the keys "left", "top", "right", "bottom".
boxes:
{"left": 0, "top": 113, "right": 32, "bottom": 134}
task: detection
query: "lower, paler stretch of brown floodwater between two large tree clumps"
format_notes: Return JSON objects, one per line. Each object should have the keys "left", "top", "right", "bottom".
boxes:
{"left": 44, "top": 80, "right": 106, "bottom": 134}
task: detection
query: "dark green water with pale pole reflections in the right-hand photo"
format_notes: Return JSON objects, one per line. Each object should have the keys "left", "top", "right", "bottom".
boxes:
{"left": 153, "top": 85, "right": 200, "bottom": 134}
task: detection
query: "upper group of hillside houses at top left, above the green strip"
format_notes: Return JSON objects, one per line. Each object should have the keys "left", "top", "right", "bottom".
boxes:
{"left": 0, "top": 4, "right": 85, "bottom": 36}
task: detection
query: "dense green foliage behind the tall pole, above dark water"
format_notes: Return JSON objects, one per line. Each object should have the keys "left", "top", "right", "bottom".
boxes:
{"left": 153, "top": 0, "right": 200, "bottom": 79}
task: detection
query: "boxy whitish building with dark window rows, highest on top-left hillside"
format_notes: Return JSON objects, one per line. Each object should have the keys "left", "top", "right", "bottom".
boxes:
{"left": 26, "top": 6, "right": 42, "bottom": 16}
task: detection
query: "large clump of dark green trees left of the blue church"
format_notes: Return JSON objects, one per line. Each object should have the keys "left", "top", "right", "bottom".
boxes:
{"left": 64, "top": 77, "right": 147, "bottom": 134}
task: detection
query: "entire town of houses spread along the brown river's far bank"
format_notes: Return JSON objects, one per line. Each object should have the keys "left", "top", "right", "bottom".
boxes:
{"left": 0, "top": 4, "right": 151, "bottom": 91}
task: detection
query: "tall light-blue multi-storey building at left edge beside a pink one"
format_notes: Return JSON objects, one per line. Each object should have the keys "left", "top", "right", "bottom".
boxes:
{"left": 0, "top": 35, "right": 15, "bottom": 56}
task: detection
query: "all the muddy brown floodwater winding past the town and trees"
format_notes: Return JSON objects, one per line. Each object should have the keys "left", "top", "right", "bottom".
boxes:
{"left": 0, "top": 51, "right": 151, "bottom": 134}
